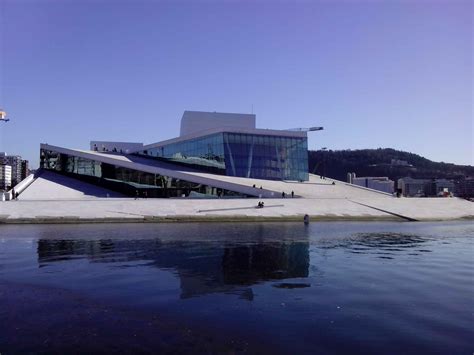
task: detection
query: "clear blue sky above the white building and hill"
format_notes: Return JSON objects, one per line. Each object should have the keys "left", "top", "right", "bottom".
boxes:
{"left": 0, "top": 0, "right": 474, "bottom": 167}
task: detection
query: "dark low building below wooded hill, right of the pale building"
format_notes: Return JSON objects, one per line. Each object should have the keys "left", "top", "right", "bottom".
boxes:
{"left": 398, "top": 177, "right": 455, "bottom": 197}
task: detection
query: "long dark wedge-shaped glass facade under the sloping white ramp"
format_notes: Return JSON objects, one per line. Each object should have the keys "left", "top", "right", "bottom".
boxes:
{"left": 40, "top": 149, "right": 252, "bottom": 198}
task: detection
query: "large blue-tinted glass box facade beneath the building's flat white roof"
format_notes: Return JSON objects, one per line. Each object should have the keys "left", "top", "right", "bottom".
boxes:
{"left": 138, "top": 132, "right": 308, "bottom": 181}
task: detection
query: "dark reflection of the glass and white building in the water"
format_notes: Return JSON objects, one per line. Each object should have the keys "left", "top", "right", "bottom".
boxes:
{"left": 38, "top": 239, "right": 309, "bottom": 299}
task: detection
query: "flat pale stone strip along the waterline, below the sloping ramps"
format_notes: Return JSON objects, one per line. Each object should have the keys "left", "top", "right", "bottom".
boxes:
{"left": 0, "top": 198, "right": 474, "bottom": 223}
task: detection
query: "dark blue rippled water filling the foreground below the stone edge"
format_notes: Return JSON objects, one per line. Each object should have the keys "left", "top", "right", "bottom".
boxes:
{"left": 0, "top": 222, "right": 474, "bottom": 354}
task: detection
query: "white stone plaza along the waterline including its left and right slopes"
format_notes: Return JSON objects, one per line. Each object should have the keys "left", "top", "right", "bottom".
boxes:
{"left": 0, "top": 175, "right": 474, "bottom": 223}
